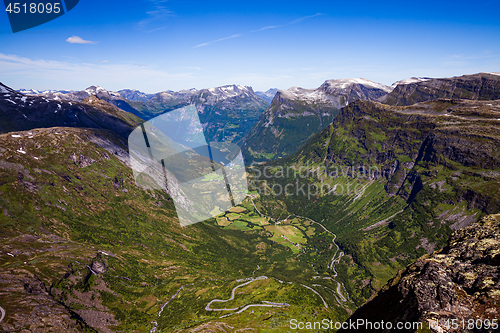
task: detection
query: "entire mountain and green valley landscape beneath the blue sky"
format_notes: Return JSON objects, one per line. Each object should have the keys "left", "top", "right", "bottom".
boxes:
{"left": 0, "top": 73, "right": 500, "bottom": 332}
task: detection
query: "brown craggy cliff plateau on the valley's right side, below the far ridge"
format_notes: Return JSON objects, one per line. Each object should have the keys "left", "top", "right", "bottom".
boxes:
{"left": 298, "top": 99, "right": 500, "bottom": 213}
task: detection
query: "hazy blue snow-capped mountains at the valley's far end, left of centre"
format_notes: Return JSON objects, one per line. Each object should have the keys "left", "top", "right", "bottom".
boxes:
{"left": 21, "top": 85, "right": 271, "bottom": 142}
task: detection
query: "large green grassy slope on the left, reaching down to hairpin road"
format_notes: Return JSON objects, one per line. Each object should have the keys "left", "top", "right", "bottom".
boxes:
{"left": 0, "top": 128, "right": 350, "bottom": 332}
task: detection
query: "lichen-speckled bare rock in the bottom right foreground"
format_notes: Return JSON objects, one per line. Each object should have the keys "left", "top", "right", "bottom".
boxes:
{"left": 339, "top": 214, "right": 500, "bottom": 332}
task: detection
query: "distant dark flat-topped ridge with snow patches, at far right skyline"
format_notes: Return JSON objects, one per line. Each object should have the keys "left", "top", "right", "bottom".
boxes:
{"left": 380, "top": 73, "right": 500, "bottom": 105}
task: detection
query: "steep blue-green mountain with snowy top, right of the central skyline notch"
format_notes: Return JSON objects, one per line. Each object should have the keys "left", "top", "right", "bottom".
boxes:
{"left": 243, "top": 79, "right": 391, "bottom": 161}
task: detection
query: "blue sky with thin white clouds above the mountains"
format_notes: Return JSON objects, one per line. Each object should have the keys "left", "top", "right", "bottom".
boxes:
{"left": 0, "top": 0, "right": 500, "bottom": 93}
